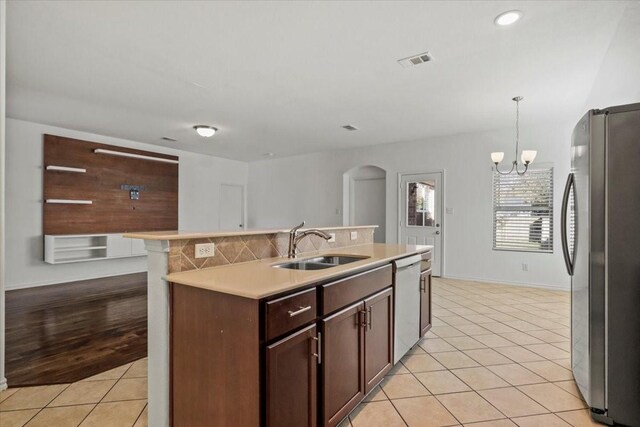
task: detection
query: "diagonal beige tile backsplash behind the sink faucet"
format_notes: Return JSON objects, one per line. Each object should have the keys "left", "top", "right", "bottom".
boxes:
{"left": 169, "top": 228, "right": 375, "bottom": 273}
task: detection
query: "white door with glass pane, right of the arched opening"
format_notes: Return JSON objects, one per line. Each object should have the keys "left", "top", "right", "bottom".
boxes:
{"left": 398, "top": 172, "right": 444, "bottom": 276}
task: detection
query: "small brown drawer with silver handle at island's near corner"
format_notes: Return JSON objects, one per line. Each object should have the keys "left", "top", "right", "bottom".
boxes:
{"left": 264, "top": 288, "right": 317, "bottom": 341}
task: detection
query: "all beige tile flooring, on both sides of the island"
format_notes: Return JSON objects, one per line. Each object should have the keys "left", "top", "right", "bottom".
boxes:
{"left": 0, "top": 279, "right": 599, "bottom": 427}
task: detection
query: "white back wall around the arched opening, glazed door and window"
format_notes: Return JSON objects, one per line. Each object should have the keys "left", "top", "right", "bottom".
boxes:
{"left": 248, "top": 123, "right": 573, "bottom": 289}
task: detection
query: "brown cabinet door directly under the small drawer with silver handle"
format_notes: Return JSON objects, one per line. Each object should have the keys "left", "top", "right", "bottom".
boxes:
{"left": 266, "top": 325, "right": 318, "bottom": 427}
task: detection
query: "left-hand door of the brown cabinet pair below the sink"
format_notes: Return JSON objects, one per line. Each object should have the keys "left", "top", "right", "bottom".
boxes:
{"left": 320, "top": 302, "right": 365, "bottom": 426}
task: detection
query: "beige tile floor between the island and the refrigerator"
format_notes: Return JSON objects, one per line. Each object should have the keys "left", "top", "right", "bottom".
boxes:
{"left": 339, "top": 279, "right": 600, "bottom": 427}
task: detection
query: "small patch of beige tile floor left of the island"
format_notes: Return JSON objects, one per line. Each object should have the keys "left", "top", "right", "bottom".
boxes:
{"left": 0, "top": 358, "right": 147, "bottom": 427}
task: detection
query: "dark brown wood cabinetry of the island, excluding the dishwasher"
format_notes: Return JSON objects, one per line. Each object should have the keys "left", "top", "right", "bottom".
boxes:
{"left": 170, "top": 258, "right": 420, "bottom": 427}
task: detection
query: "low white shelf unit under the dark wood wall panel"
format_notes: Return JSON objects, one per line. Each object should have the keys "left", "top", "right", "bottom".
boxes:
{"left": 44, "top": 234, "right": 147, "bottom": 264}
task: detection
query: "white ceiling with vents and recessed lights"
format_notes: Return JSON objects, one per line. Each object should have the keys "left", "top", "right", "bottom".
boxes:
{"left": 7, "top": 1, "right": 628, "bottom": 161}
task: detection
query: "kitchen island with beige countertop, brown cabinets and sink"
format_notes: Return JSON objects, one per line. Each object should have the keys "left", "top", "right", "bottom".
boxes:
{"left": 129, "top": 227, "right": 430, "bottom": 426}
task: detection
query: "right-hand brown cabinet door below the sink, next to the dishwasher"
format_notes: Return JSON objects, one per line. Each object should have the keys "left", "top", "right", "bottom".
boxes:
{"left": 364, "top": 288, "right": 393, "bottom": 393}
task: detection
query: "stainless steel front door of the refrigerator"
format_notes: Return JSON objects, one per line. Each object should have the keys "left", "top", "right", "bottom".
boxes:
{"left": 563, "top": 111, "right": 605, "bottom": 410}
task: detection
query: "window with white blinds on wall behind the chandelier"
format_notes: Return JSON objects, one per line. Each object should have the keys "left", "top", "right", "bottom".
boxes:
{"left": 493, "top": 168, "right": 553, "bottom": 252}
